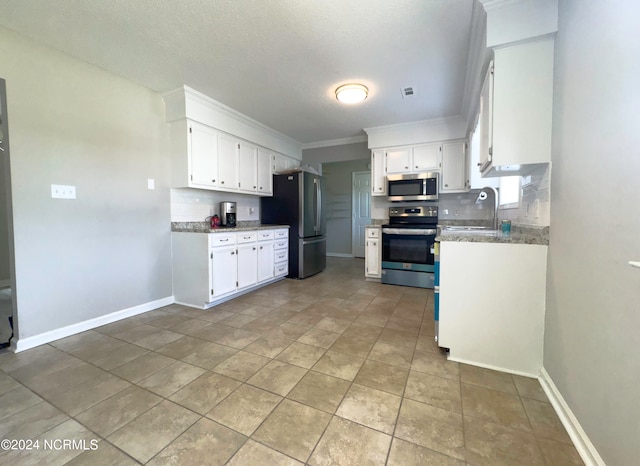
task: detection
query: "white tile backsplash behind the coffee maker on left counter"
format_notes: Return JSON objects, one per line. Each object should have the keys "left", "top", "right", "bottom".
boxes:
{"left": 171, "top": 188, "right": 260, "bottom": 222}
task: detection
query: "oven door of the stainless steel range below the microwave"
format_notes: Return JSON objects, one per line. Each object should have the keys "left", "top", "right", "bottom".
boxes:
{"left": 382, "top": 227, "right": 437, "bottom": 272}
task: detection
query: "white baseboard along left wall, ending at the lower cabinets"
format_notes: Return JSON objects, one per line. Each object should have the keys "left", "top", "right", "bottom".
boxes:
{"left": 11, "top": 296, "right": 175, "bottom": 353}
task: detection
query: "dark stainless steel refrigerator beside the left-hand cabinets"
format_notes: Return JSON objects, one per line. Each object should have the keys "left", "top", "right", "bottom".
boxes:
{"left": 260, "top": 171, "right": 327, "bottom": 278}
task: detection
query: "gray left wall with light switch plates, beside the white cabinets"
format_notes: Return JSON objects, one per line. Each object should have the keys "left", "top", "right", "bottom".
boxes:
{"left": 0, "top": 29, "right": 172, "bottom": 338}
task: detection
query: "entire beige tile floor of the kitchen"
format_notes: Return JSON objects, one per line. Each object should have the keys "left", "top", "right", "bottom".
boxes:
{"left": 0, "top": 258, "right": 582, "bottom": 466}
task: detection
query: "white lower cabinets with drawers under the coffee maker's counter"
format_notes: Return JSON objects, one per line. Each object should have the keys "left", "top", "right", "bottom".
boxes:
{"left": 172, "top": 229, "right": 289, "bottom": 309}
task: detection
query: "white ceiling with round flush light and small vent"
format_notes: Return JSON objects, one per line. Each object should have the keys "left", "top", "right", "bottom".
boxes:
{"left": 0, "top": 0, "right": 475, "bottom": 144}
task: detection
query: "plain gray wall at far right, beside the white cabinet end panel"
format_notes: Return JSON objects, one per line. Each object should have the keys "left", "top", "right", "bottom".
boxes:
{"left": 544, "top": 0, "right": 640, "bottom": 466}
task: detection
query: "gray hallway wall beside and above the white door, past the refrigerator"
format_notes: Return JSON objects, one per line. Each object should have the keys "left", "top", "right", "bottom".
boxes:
{"left": 322, "top": 158, "right": 371, "bottom": 255}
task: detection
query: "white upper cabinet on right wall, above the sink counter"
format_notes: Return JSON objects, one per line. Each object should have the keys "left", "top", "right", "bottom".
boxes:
{"left": 480, "top": 37, "right": 554, "bottom": 176}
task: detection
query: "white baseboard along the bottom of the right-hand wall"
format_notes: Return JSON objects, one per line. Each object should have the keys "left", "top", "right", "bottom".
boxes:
{"left": 538, "top": 367, "right": 606, "bottom": 466}
